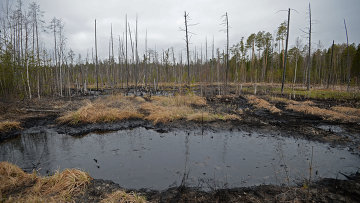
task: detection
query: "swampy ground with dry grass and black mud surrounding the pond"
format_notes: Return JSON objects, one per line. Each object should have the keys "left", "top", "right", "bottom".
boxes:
{"left": 0, "top": 83, "right": 360, "bottom": 202}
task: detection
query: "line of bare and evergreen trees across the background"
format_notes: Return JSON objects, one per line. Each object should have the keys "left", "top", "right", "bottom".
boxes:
{"left": 0, "top": 0, "right": 360, "bottom": 99}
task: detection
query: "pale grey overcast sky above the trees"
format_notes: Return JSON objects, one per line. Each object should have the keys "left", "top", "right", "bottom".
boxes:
{"left": 6, "top": 0, "right": 360, "bottom": 57}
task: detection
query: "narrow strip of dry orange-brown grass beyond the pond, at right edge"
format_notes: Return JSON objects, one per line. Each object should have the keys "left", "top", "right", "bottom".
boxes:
{"left": 285, "top": 104, "right": 360, "bottom": 123}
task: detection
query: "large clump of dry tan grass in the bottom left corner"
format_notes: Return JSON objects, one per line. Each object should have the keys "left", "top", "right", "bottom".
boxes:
{"left": 0, "top": 162, "right": 92, "bottom": 202}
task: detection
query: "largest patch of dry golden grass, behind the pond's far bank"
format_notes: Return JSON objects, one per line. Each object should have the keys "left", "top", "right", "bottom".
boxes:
{"left": 58, "top": 94, "right": 239, "bottom": 125}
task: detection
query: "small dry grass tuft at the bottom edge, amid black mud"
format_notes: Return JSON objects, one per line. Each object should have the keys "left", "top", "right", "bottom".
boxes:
{"left": 101, "top": 190, "right": 146, "bottom": 203}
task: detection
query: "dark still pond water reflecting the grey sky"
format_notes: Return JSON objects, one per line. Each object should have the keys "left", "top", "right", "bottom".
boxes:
{"left": 0, "top": 128, "right": 360, "bottom": 190}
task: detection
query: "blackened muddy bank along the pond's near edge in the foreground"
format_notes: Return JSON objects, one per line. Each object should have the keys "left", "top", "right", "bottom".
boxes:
{"left": 75, "top": 173, "right": 360, "bottom": 202}
